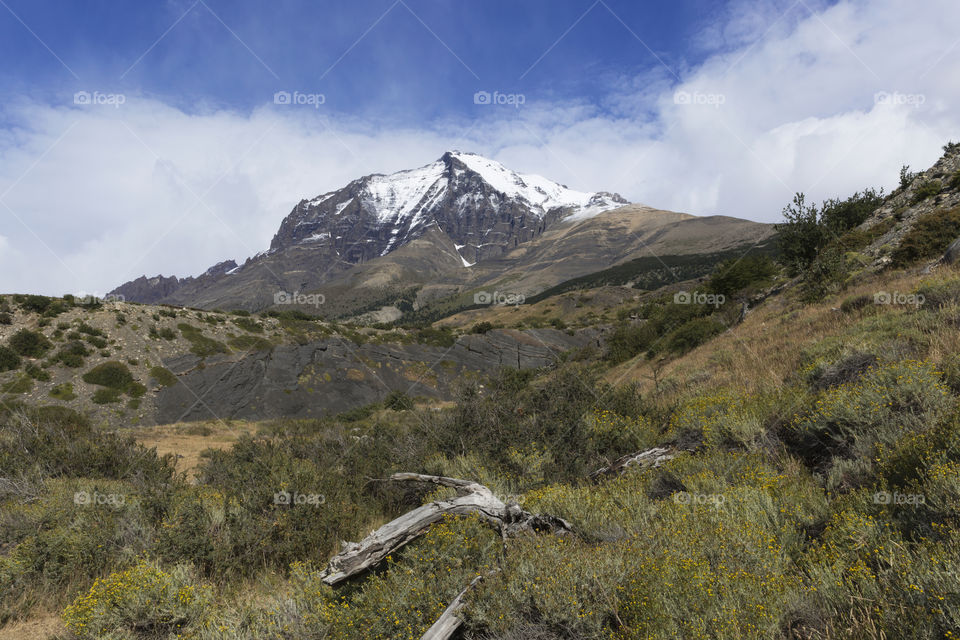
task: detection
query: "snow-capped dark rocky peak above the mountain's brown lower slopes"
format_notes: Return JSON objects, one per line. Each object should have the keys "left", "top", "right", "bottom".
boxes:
{"left": 271, "top": 151, "right": 628, "bottom": 265}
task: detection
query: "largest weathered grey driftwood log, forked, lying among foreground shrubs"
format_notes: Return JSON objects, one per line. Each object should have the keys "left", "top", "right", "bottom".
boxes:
{"left": 322, "top": 473, "right": 571, "bottom": 585}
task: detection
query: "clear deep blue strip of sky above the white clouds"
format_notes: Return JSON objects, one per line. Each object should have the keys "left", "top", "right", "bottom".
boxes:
{"left": 0, "top": 0, "right": 736, "bottom": 124}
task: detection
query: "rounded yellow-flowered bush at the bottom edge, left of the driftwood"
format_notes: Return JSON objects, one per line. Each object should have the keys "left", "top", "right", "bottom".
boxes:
{"left": 63, "top": 560, "right": 213, "bottom": 640}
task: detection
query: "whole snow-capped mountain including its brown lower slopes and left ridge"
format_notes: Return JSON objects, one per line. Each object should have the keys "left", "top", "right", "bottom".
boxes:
{"left": 113, "top": 151, "right": 771, "bottom": 317}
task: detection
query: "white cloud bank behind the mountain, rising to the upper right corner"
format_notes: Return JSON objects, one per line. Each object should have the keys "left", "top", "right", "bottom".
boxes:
{"left": 0, "top": 0, "right": 960, "bottom": 294}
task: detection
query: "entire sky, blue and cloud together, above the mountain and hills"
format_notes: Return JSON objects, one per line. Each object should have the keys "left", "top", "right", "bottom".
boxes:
{"left": 0, "top": 0, "right": 960, "bottom": 295}
